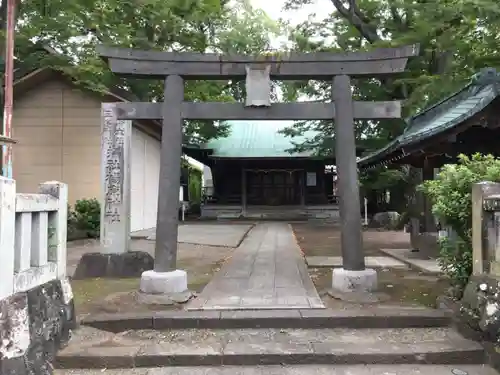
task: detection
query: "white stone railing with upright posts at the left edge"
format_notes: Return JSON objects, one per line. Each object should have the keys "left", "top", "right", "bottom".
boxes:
{"left": 0, "top": 177, "right": 68, "bottom": 300}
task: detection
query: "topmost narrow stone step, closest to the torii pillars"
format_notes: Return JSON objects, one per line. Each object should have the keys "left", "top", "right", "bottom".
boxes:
{"left": 80, "top": 308, "right": 451, "bottom": 333}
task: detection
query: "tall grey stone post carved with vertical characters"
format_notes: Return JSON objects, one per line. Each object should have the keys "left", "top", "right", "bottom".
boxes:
{"left": 101, "top": 103, "right": 132, "bottom": 254}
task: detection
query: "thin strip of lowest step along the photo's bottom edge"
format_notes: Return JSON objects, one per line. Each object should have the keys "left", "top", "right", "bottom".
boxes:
{"left": 54, "top": 365, "right": 498, "bottom": 375}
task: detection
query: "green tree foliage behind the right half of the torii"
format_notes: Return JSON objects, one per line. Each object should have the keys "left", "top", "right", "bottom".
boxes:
{"left": 287, "top": 0, "right": 500, "bottom": 152}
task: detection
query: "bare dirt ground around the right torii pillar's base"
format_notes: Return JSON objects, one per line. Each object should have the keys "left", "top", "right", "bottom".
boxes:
{"left": 292, "top": 223, "right": 449, "bottom": 309}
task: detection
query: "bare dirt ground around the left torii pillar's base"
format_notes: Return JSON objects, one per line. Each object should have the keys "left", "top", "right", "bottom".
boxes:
{"left": 68, "top": 240, "right": 234, "bottom": 316}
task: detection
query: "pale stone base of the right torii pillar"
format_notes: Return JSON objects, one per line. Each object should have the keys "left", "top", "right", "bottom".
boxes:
{"left": 332, "top": 268, "right": 378, "bottom": 293}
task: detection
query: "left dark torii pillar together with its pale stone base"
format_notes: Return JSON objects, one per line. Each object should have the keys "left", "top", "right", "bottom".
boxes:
{"left": 140, "top": 75, "right": 191, "bottom": 304}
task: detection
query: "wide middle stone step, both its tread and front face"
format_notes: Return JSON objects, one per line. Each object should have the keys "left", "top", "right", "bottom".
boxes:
{"left": 55, "top": 327, "right": 485, "bottom": 368}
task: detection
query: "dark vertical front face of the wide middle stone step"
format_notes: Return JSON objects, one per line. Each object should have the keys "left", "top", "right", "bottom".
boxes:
{"left": 55, "top": 347, "right": 485, "bottom": 369}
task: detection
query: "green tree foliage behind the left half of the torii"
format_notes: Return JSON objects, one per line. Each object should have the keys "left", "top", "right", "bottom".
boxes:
{"left": 7, "top": 0, "right": 281, "bottom": 140}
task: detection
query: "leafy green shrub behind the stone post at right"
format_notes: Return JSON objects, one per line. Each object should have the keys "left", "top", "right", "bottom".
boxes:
{"left": 420, "top": 154, "right": 500, "bottom": 296}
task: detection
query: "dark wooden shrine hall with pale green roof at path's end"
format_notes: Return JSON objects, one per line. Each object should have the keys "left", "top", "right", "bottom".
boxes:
{"left": 183, "top": 121, "right": 364, "bottom": 219}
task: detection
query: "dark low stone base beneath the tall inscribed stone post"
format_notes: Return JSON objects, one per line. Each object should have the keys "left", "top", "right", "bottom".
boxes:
{"left": 72, "top": 251, "right": 154, "bottom": 280}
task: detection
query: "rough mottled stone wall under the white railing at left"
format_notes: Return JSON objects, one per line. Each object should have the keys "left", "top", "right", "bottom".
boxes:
{"left": 0, "top": 279, "right": 76, "bottom": 375}
